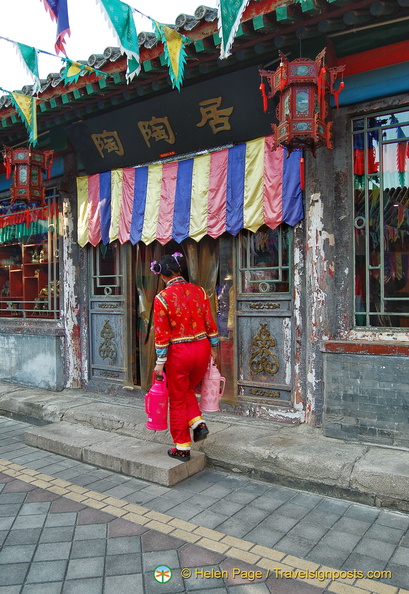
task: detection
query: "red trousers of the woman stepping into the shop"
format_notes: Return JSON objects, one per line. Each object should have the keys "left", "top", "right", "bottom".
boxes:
{"left": 166, "top": 338, "right": 210, "bottom": 447}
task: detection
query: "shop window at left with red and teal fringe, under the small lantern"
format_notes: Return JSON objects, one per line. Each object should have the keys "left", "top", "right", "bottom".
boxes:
{"left": 0, "top": 188, "right": 60, "bottom": 318}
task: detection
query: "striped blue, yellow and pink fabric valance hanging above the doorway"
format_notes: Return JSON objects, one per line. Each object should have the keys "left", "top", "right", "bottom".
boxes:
{"left": 77, "top": 136, "right": 304, "bottom": 246}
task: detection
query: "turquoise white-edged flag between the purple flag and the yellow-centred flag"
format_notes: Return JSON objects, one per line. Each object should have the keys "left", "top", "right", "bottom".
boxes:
{"left": 97, "top": 0, "right": 141, "bottom": 82}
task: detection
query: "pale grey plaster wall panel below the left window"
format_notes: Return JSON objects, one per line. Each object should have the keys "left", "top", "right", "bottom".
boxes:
{"left": 0, "top": 334, "right": 65, "bottom": 391}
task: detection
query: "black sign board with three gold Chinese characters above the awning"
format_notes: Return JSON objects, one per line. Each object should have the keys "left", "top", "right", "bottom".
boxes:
{"left": 67, "top": 67, "right": 274, "bottom": 174}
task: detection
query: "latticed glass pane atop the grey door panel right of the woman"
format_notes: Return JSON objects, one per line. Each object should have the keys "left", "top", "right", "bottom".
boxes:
{"left": 239, "top": 225, "right": 291, "bottom": 295}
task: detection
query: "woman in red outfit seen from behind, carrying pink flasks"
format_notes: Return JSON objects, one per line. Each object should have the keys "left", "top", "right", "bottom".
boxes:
{"left": 151, "top": 252, "right": 219, "bottom": 461}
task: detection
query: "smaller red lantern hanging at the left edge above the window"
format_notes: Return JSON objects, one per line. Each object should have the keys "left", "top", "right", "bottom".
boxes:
{"left": 3, "top": 147, "right": 54, "bottom": 206}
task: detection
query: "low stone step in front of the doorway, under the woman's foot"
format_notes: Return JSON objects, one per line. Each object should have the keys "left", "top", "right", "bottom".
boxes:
{"left": 24, "top": 421, "right": 206, "bottom": 487}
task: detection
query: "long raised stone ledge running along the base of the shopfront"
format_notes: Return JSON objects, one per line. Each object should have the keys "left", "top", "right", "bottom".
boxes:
{"left": 0, "top": 382, "right": 409, "bottom": 511}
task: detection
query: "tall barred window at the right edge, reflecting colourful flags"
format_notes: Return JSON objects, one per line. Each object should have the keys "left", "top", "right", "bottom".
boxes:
{"left": 352, "top": 110, "right": 409, "bottom": 328}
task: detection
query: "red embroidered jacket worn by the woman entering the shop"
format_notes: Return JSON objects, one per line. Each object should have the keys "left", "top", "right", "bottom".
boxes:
{"left": 153, "top": 276, "right": 219, "bottom": 358}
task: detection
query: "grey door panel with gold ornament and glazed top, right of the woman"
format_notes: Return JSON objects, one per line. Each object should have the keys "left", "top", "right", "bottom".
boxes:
{"left": 236, "top": 226, "right": 294, "bottom": 407}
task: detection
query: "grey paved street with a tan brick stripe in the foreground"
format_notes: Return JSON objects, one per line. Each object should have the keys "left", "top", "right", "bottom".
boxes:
{"left": 0, "top": 417, "right": 409, "bottom": 594}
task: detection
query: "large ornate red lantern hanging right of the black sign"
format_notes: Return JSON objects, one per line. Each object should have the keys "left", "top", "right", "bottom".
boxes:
{"left": 259, "top": 49, "right": 345, "bottom": 157}
